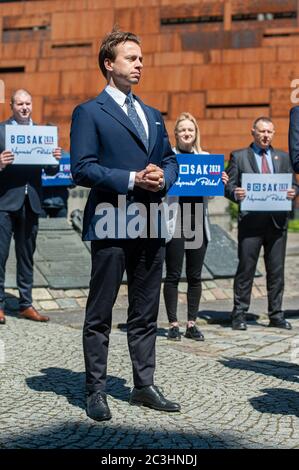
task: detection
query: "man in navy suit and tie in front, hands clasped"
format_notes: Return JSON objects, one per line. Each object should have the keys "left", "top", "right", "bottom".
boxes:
{"left": 71, "top": 31, "right": 180, "bottom": 421}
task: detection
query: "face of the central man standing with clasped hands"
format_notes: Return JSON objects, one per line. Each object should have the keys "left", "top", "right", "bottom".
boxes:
{"left": 105, "top": 41, "right": 143, "bottom": 91}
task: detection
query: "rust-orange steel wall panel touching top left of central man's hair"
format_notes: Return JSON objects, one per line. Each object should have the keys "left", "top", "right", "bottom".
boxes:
{"left": 51, "top": 9, "right": 115, "bottom": 40}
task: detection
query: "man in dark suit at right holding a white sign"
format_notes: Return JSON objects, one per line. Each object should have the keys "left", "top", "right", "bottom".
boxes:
{"left": 225, "top": 117, "right": 297, "bottom": 330}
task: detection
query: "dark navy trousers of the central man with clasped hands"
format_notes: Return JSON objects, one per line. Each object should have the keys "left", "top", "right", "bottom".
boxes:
{"left": 83, "top": 239, "right": 164, "bottom": 392}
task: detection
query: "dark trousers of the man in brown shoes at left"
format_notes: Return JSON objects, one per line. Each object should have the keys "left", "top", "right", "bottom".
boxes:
{"left": 0, "top": 197, "right": 38, "bottom": 310}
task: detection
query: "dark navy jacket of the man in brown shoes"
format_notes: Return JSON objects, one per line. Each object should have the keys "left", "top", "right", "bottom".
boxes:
{"left": 0, "top": 118, "right": 59, "bottom": 214}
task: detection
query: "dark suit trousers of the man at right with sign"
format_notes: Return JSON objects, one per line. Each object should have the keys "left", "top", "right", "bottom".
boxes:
{"left": 233, "top": 215, "right": 287, "bottom": 319}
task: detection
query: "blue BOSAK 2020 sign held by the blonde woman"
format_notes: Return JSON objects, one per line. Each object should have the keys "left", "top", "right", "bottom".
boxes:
{"left": 167, "top": 153, "right": 224, "bottom": 196}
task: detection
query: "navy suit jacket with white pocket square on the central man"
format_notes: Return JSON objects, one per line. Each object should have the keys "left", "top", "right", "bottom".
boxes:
{"left": 71, "top": 91, "right": 178, "bottom": 240}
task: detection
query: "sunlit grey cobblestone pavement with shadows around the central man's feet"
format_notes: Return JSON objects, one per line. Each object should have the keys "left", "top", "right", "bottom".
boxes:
{"left": 0, "top": 317, "right": 299, "bottom": 449}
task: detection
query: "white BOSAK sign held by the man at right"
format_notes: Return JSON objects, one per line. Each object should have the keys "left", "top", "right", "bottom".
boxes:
{"left": 241, "top": 173, "right": 292, "bottom": 212}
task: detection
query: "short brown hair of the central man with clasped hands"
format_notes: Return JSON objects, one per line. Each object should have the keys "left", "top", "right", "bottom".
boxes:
{"left": 99, "top": 29, "right": 140, "bottom": 78}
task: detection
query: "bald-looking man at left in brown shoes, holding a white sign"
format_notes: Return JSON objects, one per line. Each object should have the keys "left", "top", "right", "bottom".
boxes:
{"left": 0, "top": 89, "right": 61, "bottom": 325}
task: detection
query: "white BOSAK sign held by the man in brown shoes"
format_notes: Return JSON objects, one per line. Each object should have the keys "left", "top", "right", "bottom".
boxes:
{"left": 5, "top": 125, "right": 57, "bottom": 166}
